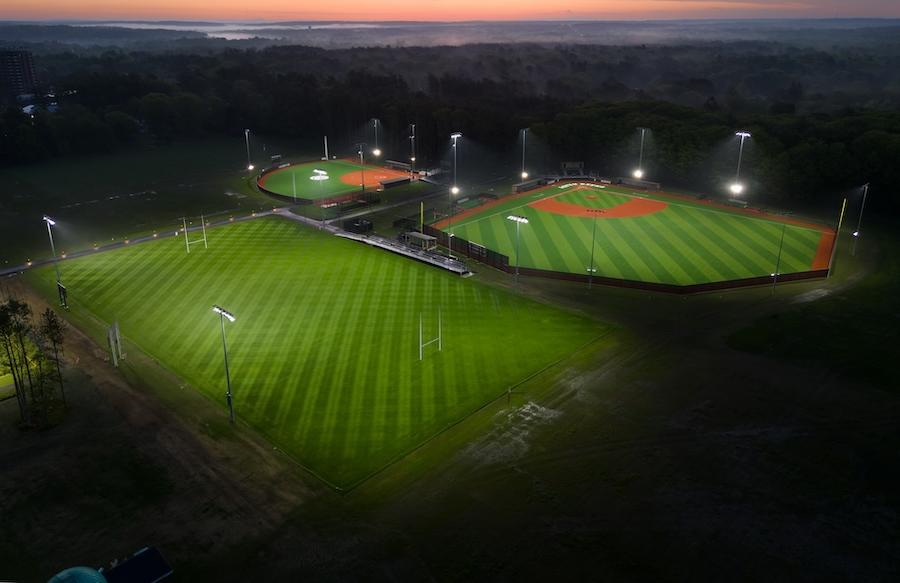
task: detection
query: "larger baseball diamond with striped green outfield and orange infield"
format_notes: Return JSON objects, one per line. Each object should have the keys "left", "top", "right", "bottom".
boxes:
{"left": 434, "top": 183, "right": 833, "bottom": 285}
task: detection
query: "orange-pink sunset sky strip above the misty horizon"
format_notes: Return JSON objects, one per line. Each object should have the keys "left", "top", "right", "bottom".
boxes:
{"left": 0, "top": 0, "right": 900, "bottom": 21}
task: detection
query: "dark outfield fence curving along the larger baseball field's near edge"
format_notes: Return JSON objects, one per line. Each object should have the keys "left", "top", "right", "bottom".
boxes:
{"left": 424, "top": 225, "right": 828, "bottom": 295}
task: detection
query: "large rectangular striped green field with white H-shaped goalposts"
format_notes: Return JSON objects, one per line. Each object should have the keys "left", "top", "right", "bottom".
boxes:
{"left": 29, "top": 217, "right": 604, "bottom": 487}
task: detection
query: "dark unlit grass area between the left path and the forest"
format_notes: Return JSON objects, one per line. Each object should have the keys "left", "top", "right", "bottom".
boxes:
{"left": 0, "top": 139, "right": 284, "bottom": 267}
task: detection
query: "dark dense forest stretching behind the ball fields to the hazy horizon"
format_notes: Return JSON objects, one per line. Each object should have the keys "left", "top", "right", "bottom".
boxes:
{"left": 0, "top": 43, "right": 900, "bottom": 210}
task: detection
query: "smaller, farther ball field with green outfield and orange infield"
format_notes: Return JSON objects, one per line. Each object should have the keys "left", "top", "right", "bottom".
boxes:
{"left": 259, "top": 160, "right": 409, "bottom": 200}
